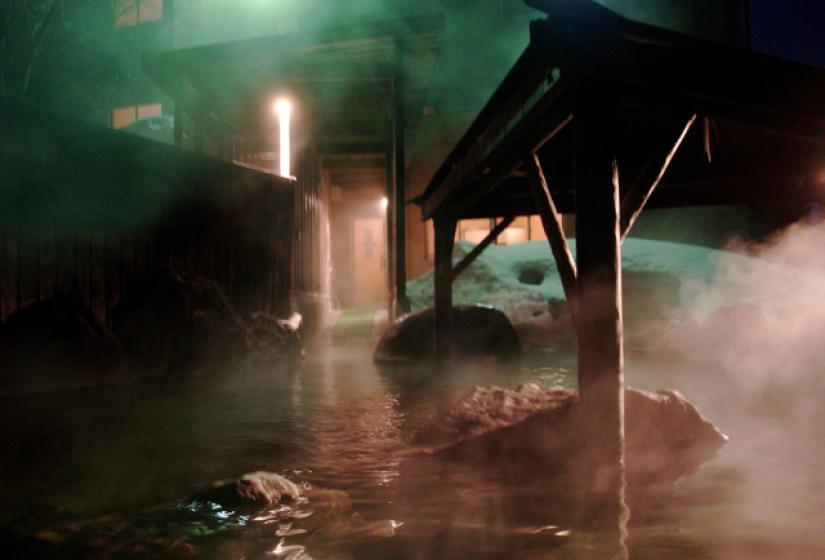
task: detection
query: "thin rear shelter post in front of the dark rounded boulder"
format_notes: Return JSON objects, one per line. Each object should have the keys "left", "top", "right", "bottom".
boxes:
{"left": 433, "top": 216, "right": 456, "bottom": 364}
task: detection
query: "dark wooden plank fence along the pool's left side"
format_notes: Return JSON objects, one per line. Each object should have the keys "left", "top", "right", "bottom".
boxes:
{"left": 0, "top": 108, "right": 295, "bottom": 322}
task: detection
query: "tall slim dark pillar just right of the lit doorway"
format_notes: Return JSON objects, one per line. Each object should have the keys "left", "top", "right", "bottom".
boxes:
{"left": 391, "top": 42, "right": 410, "bottom": 316}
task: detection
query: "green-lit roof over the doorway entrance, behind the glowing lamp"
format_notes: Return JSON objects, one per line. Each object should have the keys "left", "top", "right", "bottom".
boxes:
{"left": 144, "top": 16, "right": 444, "bottom": 177}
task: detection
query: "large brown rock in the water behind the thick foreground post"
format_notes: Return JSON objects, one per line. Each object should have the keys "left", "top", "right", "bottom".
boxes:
{"left": 419, "top": 384, "right": 727, "bottom": 486}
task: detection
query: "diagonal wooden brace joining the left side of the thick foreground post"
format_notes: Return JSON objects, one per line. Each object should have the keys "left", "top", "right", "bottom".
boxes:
{"left": 525, "top": 153, "right": 577, "bottom": 323}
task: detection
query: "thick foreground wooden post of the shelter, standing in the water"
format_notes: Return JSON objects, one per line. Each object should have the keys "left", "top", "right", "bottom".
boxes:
{"left": 574, "top": 99, "right": 627, "bottom": 533}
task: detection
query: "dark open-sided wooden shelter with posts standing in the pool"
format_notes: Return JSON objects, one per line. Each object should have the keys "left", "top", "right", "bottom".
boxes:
{"left": 415, "top": 0, "right": 825, "bottom": 528}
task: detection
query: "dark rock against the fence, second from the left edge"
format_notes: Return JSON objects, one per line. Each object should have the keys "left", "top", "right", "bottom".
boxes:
{"left": 112, "top": 272, "right": 247, "bottom": 374}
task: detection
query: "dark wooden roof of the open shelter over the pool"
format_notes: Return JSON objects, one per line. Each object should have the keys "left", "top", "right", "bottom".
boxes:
{"left": 414, "top": 0, "right": 825, "bottom": 223}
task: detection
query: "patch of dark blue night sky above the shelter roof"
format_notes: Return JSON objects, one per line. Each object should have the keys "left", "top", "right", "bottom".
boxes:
{"left": 751, "top": 0, "right": 825, "bottom": 68}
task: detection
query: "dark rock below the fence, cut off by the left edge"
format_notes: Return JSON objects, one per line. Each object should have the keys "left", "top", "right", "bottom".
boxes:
{"left": 0, "top": 296, "right": 122, "bottom": 395}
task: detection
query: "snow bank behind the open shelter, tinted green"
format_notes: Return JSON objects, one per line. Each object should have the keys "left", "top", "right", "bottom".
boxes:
{"left": 407, "top": 238, "right": 812, "bottom": 345}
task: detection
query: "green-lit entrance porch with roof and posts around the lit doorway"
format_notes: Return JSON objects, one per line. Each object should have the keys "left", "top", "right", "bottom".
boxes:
{"left": 144, "top": 16, "right": 444, "bottom": 316}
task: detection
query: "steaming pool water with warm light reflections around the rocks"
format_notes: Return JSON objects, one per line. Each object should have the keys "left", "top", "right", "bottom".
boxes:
{"left": 0, "top": 344, "right": 825, "bottom": 560}
